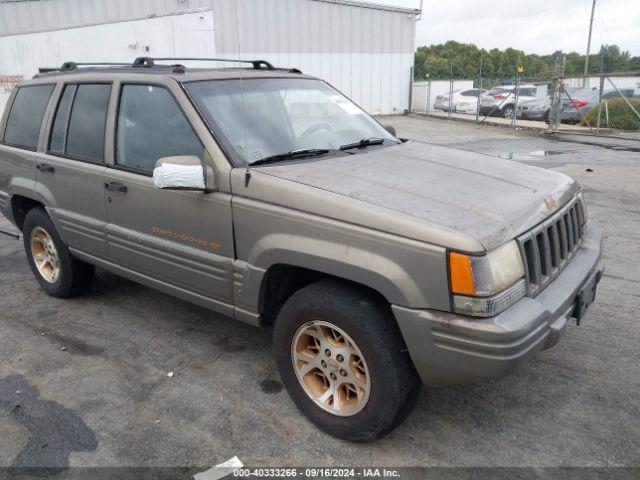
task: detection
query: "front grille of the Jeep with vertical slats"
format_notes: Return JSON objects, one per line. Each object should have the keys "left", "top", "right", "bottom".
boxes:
{"left": 517, "top": 197, "right": 586, "bottom": 297}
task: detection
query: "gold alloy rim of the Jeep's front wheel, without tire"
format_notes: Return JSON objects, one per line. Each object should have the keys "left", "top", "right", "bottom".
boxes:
{"left": 291, "top": 321, "right": 371, "bottom": 417}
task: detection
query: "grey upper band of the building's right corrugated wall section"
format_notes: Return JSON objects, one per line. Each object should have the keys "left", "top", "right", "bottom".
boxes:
{"left": 213, "top": 0, "right": 415, "bottom": 54}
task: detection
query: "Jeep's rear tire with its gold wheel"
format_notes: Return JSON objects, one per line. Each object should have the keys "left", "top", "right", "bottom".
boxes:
{"left": 22, "top": 208, "right": 95, "bottom": 298}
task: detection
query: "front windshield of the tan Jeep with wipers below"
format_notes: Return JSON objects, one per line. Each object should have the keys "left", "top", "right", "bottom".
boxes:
{"left": 185, "top": 78, "right": 399, "bottom": 165}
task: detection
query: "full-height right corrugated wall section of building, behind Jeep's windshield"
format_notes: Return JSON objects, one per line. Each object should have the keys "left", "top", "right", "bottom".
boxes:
{"left": 214, "top": 0, "right": 415, "bottom": 114}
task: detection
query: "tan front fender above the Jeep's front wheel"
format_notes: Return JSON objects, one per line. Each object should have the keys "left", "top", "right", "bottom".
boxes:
{"left": 234, "top": 198, "right": 449, "bottom": 310}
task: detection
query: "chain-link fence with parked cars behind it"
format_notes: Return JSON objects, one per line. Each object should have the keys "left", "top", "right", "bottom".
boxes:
{"left": 412, "top": 57, "right": 640, "bottom": 139}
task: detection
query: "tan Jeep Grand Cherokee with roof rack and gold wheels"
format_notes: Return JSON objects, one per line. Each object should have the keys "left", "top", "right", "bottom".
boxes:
{"left": 0, "top": 58, "right": 604, "bottom": 441}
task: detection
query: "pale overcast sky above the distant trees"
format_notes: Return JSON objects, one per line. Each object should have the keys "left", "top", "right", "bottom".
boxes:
{"left": 366, "top": 0, "right": 640, "bottom": 55}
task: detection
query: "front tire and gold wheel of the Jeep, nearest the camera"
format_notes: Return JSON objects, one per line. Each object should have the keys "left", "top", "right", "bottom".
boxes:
{"left": 274, "top": 281, "right": 421, "bottom": 442}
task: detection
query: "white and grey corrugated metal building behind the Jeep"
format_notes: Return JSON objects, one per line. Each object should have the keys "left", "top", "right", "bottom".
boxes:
{"left": 0, "top": 0, "right": 420, "bottom": 114}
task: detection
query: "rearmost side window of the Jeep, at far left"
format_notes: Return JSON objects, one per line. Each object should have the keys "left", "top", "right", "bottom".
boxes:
{"left": 3, "top": 85, "right": 53, "bottom": 150}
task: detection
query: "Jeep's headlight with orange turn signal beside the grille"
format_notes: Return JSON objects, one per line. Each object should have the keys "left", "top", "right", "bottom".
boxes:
{"left": 449, "top": 240, "right": 526, "bottom": 317}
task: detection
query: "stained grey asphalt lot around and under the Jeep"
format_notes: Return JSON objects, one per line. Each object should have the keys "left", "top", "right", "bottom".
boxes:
{"left": 0, "top": 116, "right": 640, "bottom": 476}
